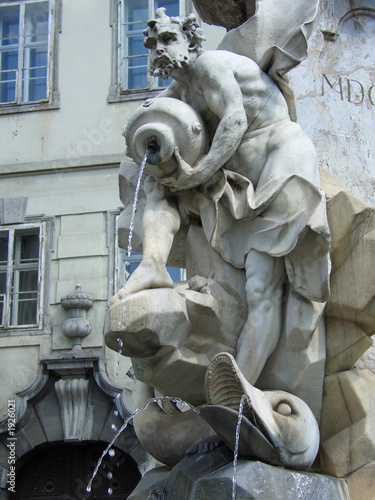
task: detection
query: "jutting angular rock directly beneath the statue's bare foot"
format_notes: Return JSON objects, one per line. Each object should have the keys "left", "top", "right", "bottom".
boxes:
{"left": 105, "top": 277, "right": 247, "bottom": 405}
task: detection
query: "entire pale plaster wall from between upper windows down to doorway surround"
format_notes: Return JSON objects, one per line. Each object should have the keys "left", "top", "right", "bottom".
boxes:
{"left": 0, "top": 0, "right": 135, "bottom": 426}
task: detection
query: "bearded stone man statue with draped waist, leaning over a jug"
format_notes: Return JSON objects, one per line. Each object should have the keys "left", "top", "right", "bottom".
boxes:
{"left": 118, "top": 9, "right": 329, "bottom": 384}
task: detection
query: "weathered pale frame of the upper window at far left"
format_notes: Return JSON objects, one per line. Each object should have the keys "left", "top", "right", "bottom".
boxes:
{"left": 0, "top": 0, "right": 61, "bottom": 115}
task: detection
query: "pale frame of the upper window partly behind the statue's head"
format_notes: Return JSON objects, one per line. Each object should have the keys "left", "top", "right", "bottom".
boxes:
{"left": 108, "top": 0, "right": 193, "bottom": 103}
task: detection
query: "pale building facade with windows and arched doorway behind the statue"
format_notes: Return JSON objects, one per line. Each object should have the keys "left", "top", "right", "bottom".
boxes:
{"left": 0, "top": 0, "right": 206, "bottom": 499}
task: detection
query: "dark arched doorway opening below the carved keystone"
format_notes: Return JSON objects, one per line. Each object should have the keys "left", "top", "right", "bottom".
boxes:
{"left": 9, "top": 443, "right": 141, "bottom": 500}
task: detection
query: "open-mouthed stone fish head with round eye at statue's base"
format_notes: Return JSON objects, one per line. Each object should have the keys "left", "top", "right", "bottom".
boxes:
{"left": 200, "top": 353, "right": 319, "bottom": 469}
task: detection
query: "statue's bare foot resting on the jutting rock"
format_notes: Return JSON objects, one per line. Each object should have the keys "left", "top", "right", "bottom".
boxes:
{"left": 110, "top": 259, "right": 173, "bottom": 305}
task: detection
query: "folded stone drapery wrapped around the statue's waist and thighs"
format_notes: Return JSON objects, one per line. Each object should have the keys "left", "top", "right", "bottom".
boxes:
{"left": 197, "top": 169, "right": 330, "bottom": 302}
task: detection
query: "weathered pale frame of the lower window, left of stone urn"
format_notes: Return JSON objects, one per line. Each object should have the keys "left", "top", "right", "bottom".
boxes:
{"left": 0, "top": 218, "right": 53, "bottom": 337}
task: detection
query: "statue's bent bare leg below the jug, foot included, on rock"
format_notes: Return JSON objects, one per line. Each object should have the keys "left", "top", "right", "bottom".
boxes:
{"left": 118, "top": 177, "right": 180, "bottom": 297}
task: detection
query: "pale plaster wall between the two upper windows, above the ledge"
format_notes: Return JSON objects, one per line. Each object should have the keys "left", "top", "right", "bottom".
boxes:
{"left": 0, "top": 0, "right": 137, "bottom": 169}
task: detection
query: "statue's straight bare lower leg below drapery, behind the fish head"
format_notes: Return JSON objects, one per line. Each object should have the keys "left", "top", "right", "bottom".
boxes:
{"left": 236, "top": 250, "right": 285, "bottom": 384}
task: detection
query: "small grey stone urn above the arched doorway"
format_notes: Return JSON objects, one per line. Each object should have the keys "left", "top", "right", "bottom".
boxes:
{"left": 61, "top": 283, "right": 94, "bottom": 350}
